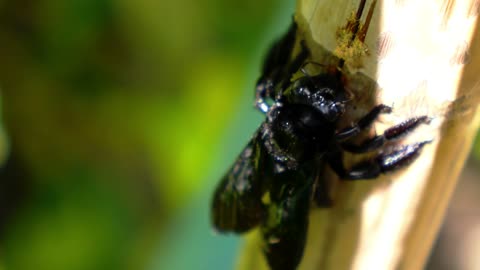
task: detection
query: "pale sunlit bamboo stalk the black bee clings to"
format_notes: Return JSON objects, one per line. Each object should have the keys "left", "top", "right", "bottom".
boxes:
{"left": 239, "top": 0, "right": 480, "bottom": 270}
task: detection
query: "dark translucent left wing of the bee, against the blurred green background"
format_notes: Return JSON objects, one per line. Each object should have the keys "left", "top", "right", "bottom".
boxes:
{"left": 212, "top": 132, "right": 267, "bottom": 233}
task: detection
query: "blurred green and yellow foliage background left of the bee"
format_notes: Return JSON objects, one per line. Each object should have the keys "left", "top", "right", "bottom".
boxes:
{"left": 0, "top": 0, "right": 480, "bottom": 270}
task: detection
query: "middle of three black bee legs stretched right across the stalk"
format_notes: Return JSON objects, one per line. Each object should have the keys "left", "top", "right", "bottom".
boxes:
{"left": 342, "top": 116, "right": 431, "bottom": 153}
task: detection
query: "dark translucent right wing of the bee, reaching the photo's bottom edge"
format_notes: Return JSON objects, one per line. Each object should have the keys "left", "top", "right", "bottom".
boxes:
{"left": 262, "top": 171, "right": 312, "bottom": 270}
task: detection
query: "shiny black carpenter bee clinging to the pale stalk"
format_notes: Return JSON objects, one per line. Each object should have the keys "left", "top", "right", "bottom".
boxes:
{"left": 212, "top": 23, "right": 429, "bottom": 270}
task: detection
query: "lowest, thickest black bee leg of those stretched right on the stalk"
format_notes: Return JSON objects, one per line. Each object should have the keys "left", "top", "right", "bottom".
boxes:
{"left": 328, "top": 141, "right": 431, "bottom": 180}
